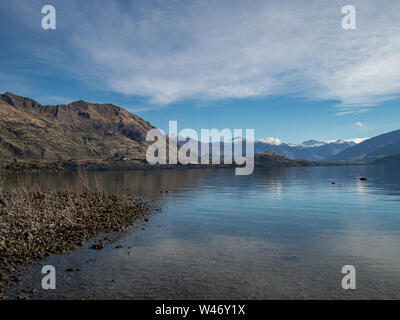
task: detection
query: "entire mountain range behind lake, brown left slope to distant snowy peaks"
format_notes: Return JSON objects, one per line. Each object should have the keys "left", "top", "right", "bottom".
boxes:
{"left": 0, "top": 92, "right": 400, "bottom": 165}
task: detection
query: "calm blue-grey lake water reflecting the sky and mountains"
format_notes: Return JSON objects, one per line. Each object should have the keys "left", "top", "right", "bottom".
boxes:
{"left": 6, "top": 166, "right": 400, "bottom": 299}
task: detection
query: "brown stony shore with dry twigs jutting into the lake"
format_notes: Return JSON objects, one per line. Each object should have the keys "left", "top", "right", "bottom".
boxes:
{"left": 0, "top": 188, "right": 155, "bottom": 299}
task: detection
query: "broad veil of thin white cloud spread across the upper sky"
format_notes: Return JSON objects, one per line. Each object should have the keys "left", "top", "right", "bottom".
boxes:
{"left": 2, "top": 0, "right": 400, "bottom": 110}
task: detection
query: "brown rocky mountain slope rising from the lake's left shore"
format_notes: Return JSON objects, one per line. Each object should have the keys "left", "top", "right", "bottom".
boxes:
{"left": 0, "top": 93, "right": 159, "bottom": 160}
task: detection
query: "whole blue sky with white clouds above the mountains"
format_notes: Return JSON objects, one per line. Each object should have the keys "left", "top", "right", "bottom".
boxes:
{"left": 0, "top": 0, "right": 400, "bottom": 143}
